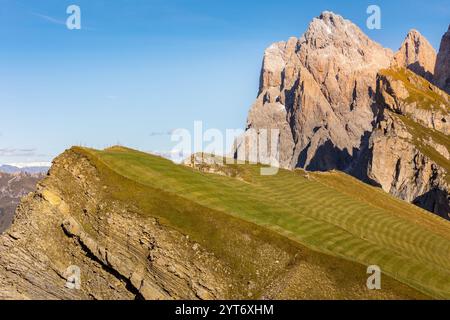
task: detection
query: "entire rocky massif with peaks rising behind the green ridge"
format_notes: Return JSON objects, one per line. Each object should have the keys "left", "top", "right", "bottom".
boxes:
{"left": 235, "top": 12, "right": 450, "bottom": 217}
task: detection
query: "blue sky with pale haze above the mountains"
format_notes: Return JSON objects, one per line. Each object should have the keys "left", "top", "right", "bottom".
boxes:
{"left": 0, "top": 0, "right": 450, "bottom": 163}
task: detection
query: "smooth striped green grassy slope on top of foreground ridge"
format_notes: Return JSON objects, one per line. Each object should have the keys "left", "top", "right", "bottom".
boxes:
{"left": 77, "top": 148, "right": 450, "bottom": 298}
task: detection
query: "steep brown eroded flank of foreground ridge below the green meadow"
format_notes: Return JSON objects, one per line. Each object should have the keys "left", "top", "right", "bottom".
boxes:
{"left": 0, "top": 148, "right": 423, "bottom": 299}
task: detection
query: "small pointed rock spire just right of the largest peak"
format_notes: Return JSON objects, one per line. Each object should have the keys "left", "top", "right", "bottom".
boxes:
{"left": 392, "top": 30, "right": 436, "bottom": 81}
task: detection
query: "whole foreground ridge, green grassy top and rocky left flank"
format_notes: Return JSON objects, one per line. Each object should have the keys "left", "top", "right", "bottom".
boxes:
{"left": 0, "top": 148, "right": 450, "bottom": 299}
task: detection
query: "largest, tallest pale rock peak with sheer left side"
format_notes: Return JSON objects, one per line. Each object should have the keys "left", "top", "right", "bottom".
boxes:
{"left": 236, "top": 12, "right": 392, "bottom": 170}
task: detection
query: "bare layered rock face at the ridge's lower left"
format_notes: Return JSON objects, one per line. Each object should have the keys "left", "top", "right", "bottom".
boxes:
{"left": 0, "top": 151, "right": 226, "bottom": 299}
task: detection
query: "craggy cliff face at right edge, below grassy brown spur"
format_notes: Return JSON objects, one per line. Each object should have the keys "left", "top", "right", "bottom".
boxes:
{"left": 368, "top": 110, "right": 450, "bottom": 219}
